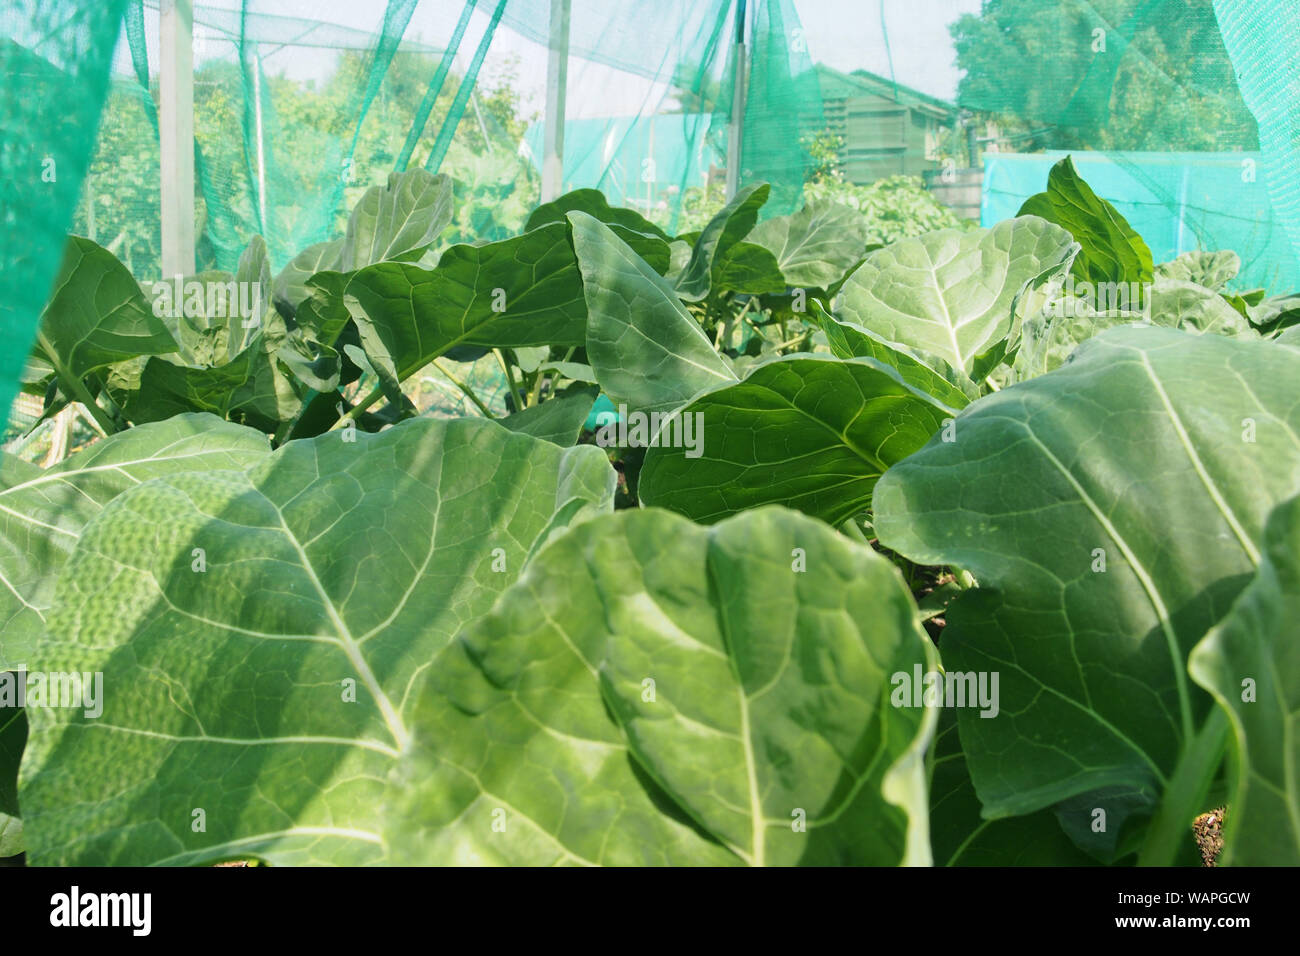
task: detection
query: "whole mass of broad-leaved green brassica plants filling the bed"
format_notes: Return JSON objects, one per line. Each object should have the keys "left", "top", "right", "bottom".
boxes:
{"left": 0, "top": 160, "right": 1300, "bottom": 865}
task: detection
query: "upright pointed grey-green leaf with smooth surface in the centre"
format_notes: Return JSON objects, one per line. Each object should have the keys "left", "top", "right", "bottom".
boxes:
{"left": 569, "top": 212, "right": 736, "bottom": 414}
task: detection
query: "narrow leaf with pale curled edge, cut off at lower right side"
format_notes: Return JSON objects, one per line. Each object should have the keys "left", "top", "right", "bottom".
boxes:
{"left": 1190, "top": 498, "right": 1300, "bottom": 866}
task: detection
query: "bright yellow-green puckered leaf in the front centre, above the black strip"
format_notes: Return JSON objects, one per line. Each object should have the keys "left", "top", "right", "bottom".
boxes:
{"left": 386, "top": 509, "right": 936, "bottom": 865}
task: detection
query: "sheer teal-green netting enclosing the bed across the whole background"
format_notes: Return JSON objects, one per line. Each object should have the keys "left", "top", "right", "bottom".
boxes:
{"left": 0, "top": 0, "right": 1300, "bottom": 424}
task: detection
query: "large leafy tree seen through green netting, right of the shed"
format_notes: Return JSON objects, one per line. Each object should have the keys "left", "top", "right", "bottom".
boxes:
{"left": 949, "top": 0, "right": 1258, "bottom": 151}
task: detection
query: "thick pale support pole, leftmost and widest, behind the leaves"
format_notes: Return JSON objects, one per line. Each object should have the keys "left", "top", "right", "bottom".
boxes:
{"left": 159, "top": 0, "right": 194, "bottom": 276}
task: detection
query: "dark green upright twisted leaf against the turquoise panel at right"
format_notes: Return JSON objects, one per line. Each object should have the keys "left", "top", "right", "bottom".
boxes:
{"left": 1017, "top": 156, "right": 1154, "bottom": 284}
